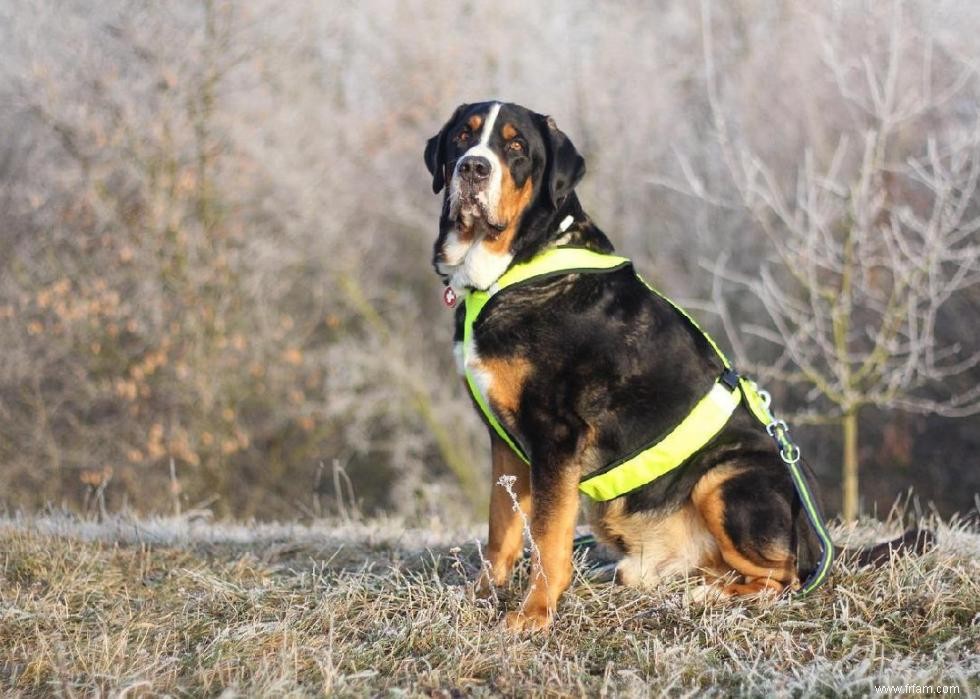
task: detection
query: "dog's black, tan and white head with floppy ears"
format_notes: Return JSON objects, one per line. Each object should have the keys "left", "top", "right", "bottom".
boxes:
{"left": 425, "top": 102, "right": 585, "bottom": 289}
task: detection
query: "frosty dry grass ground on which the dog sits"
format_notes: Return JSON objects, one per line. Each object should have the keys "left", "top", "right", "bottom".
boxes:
{"left": 0, "top": 515, "right": 980, "bottom": 696}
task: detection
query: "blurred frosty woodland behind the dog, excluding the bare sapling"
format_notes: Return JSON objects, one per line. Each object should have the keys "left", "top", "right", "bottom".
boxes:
{"left": 0, "top": 0, "right": 980, "bottom": 518}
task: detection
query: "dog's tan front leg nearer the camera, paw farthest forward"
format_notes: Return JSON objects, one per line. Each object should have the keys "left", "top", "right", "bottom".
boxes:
{"left": 505, "top": 468, "right": 579, "bottom": 631}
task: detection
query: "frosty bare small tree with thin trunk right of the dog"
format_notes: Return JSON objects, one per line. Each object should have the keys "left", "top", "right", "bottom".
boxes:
{"left": 688, "top": 2, "right": 980, "bottom": 519}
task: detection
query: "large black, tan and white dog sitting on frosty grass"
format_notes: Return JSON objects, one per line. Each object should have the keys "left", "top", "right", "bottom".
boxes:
{"left": 425, "top": 102, "right": 928, "bottom": 630}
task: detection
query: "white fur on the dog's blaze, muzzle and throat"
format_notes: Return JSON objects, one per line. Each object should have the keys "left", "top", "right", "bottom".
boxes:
{"left": 438, "top": 102, "right": 513, "bottom": 289}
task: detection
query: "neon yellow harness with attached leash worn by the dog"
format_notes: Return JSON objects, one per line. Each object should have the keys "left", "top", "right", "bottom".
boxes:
{"left": 463, "top": 247, "right": 833, "bottom": 593}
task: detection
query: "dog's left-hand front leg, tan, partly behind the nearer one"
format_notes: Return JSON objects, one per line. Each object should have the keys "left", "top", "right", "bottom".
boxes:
{"left": 475, "top": 430, "right": 531, "bottom": 599}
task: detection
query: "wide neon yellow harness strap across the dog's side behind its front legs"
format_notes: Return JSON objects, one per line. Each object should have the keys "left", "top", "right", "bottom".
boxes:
{"left": 578, "top": 381, "right": 742, "bottom": 501}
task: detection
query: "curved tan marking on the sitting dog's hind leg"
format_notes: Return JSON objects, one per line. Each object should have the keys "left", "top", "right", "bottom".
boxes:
{"left": 691, "top": 466, "right": 796, "bottom": 594}
